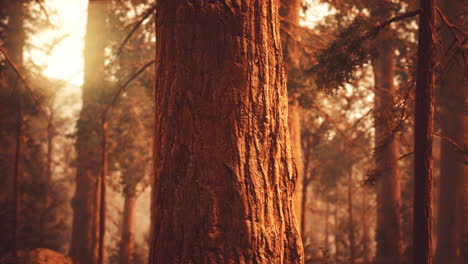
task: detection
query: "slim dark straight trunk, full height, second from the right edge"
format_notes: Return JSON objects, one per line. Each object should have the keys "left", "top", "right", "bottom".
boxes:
{"left": 413, "top": 0, "right": 435, "bottom": 264}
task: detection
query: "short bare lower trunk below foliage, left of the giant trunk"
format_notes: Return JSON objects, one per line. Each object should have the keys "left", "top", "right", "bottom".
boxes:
{"left": 119, "top": 193, "right": 136, "bottom": 264}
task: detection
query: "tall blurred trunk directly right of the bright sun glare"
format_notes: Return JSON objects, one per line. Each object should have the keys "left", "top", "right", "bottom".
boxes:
{"left": 70, "top": 0, "right": 106, "bottom": 264}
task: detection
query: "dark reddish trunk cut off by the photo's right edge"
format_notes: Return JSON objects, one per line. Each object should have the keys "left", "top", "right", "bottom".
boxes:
{"left": 435, "top": 0, "right": 468, "bottom": 264}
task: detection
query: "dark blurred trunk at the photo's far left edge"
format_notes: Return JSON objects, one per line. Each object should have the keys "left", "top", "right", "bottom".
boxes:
{"left": 0, "top": 1, "right": 25, "bottom": 255}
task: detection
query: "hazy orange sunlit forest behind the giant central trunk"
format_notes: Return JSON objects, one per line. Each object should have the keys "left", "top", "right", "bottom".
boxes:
{"left": 0, "top": 0, "right": 468, "bottom": 264}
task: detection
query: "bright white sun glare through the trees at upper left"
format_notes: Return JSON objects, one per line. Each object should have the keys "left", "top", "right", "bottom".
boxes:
{"left": 26, "top": 0, "right": 87, "bottom": 92}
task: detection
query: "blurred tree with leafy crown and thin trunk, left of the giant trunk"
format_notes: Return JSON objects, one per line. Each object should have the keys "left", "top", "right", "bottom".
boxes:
{"left": 112, "top": 85, "right": 154, "bottom": 264}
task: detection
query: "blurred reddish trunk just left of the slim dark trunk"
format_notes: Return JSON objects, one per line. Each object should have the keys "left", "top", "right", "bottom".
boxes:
{"left": 372, "top": 32, "right": 401, "bottom": 264}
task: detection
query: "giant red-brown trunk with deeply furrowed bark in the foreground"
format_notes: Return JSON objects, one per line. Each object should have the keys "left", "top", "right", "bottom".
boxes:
{"left": 150, "top": 0, "right": 303, "bottom": 264}
